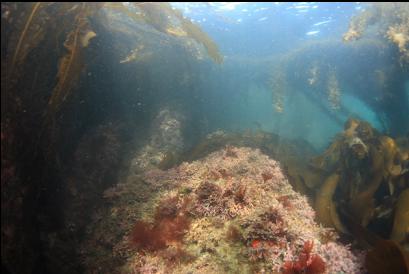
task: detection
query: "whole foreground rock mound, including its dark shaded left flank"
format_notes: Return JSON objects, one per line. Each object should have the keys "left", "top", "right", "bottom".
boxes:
{"left": 82, "top": 146, "right": 363, "bottom": 273}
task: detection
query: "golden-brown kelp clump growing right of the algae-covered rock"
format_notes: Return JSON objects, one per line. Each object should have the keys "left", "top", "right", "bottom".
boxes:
{"left": 310, "top": 119, "right": 407, "bottom": 242}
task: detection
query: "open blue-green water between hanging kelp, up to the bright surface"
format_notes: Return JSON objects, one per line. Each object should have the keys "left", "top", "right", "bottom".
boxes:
{"left": 172, "top": 2, "right": 396, "bottom": 150}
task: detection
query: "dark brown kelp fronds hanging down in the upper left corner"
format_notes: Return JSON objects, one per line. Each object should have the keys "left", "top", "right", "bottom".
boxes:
{"left": 2, "top": 2, "right": 103, "bottom": 118}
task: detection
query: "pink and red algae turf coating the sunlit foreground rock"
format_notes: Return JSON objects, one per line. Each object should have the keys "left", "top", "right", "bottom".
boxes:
{"left": 122, "top": 148, "right": 363, "bottom": 274}
